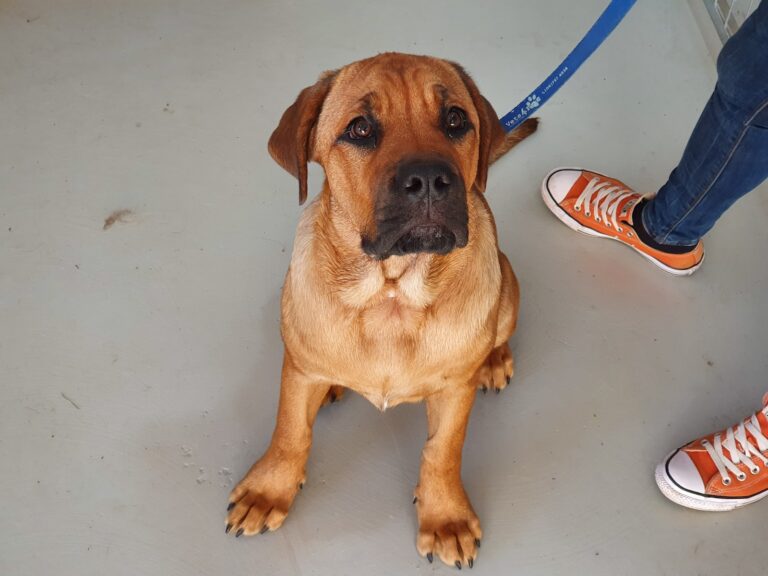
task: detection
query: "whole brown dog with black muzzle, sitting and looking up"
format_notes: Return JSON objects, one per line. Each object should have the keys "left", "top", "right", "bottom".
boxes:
{"left": 227, "top": 54, "right": 537, "bottom": 568}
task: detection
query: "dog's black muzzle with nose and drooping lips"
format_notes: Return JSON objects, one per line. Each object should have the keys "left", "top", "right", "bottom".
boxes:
{"left": 362, "top": 159, "right": 468, "bottom": 260}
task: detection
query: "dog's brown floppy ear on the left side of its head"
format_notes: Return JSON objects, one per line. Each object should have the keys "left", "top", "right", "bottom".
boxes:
{"left": 269, "top": 71, "right": 336, "bottom": 204}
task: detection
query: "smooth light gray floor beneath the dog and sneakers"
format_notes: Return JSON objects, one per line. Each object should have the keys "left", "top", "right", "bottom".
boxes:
{"left": 0, "top": 0, "right": 768, "bottom": 576}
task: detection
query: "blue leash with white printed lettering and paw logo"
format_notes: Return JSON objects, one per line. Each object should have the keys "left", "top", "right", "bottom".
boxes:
{"left": 500, "top": 0, "right": 636, "bottom": 132}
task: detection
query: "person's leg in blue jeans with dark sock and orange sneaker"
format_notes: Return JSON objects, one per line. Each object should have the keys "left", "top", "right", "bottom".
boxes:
{"left": 541, "top": 0, "right": 768, "bottom": 275}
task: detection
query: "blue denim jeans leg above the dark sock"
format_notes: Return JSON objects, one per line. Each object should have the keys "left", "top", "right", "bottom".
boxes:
{"left": 642, "top": 0, "right": 768, "bottom": 246}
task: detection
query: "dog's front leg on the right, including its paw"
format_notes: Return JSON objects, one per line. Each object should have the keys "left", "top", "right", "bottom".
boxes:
{"left": 415, "top": 384, "right": 483, "bottom": 568}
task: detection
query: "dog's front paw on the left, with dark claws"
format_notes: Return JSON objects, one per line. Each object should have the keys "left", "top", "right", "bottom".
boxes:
{"left": 226, "top": 459, "right": 304, "bottom": 537}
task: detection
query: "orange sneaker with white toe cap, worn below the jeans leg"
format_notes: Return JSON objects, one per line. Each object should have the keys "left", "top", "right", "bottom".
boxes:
{"left": 541, "top": 168, "right": 704, "bottom": 276}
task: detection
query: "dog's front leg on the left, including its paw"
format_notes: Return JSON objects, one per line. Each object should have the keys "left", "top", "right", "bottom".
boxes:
{"left": 227, "top": 352, "right": 330, "bottom": 536}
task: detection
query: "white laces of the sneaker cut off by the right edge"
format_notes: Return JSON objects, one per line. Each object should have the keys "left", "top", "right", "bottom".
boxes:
{"left": 701, "top": 406, "right": 768, "bottom": 486}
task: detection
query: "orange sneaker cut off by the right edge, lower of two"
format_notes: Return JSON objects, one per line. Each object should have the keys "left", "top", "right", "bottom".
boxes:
{"left": 656, "top": 394, "right": 768, "bottom": 512}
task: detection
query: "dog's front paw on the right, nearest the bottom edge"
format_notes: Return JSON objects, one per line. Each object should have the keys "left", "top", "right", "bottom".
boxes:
{"left": 416, "top": 490, "right": 483, "bottom": 570}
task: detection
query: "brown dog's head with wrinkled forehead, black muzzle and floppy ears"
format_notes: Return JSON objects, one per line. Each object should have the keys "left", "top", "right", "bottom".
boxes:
{"left": 269, "top": 53, "right": 498, "bottom": 259}
